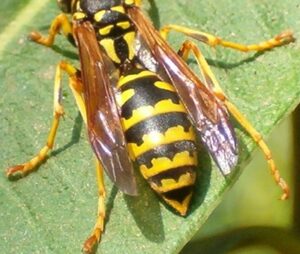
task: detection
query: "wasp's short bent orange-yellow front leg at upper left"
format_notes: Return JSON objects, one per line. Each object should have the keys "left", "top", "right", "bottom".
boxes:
{"left": 29, "top": 13, "right": 75, "bottom": 47}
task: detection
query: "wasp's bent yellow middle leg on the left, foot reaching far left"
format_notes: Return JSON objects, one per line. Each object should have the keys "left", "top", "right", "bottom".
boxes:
{"left": 6, "top": 62, "right": 86, "bottom": 180}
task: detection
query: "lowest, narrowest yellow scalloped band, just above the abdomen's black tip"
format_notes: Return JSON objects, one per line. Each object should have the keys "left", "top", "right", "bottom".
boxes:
{"left": 151, "top": 172, "right": 196, "bottom": 193}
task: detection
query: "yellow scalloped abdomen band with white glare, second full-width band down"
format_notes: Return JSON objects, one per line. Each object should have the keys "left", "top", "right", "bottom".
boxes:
{"left": 128, "top": 126, "right": 195, "bottom": 159}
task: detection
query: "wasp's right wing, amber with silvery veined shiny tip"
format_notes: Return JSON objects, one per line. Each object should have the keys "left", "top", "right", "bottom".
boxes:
{"left": 128, "top": 7, "right": 238, "bottom": 175}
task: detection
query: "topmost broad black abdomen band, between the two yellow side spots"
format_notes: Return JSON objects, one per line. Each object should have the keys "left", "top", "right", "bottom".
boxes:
{"left": 121, "top": 76, "right": 179, "bottom": 119}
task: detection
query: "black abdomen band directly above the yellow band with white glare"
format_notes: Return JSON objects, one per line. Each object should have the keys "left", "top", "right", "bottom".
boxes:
{"left": 125, "top": 112, "right": 191, "bottom": 145}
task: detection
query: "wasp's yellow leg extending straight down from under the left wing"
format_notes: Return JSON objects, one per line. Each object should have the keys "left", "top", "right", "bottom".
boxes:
{"left": 82, "top": 160, "right": 106, "bottom": 254}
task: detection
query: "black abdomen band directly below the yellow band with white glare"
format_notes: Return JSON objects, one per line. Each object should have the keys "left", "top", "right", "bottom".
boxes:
{"left": 136, "top": 140, "right": 196, "bottom": 168}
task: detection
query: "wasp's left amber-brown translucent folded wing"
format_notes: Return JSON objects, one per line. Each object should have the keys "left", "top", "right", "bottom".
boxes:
{"left": 74, "top": 22, "right": 137, "bottom": 195}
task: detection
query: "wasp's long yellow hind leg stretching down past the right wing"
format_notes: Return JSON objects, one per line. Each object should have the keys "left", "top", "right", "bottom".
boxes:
{"left": 179, "top": 41, "right": 290, "bottom": 200}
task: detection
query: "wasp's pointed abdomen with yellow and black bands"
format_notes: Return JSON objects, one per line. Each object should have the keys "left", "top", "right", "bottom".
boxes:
{"left": 118, "top": 69, "right": 197, "bottom": 215}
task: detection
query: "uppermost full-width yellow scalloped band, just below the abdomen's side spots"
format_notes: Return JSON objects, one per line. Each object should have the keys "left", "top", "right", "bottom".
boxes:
{"left": 119, "top": 99, "right": 186, "bottom": 130}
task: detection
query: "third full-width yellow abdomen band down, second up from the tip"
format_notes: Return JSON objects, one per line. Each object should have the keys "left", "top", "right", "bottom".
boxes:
{"left": 140, "top": 151, "right": 197, "bottom": 181}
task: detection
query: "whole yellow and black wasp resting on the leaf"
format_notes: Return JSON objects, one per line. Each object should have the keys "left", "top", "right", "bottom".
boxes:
{"left": 6, "top": 0, "right": 294, "bottom": 253}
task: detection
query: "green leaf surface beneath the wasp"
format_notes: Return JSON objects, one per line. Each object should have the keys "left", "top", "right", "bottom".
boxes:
{"left": 0, "top": 0, "right": 300, "bottom": 253}
